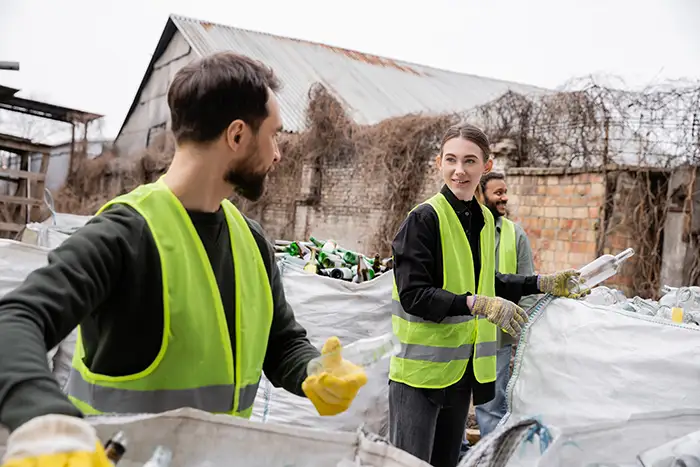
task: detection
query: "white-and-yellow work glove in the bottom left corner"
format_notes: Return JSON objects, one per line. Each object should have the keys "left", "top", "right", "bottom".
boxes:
{"left": 2, "top": 415, "right": 113, "bottom": 467}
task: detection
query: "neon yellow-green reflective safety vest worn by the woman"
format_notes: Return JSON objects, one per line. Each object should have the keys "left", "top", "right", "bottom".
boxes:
{"left": 389, "top": 193, "right": 497, "bottom": 389}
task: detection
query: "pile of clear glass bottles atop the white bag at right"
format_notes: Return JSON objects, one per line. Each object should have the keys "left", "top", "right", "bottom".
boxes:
{"left": 585, "top": 286, "right": 700, "bottom": 326}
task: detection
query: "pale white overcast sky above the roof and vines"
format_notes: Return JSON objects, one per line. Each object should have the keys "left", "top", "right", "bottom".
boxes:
{"left": 0, "top": 0, "right": 700, "bottom": 144}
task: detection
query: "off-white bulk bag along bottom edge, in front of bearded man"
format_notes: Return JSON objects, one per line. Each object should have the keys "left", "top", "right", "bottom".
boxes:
{"left": 0, "top": 409, "right": 430, "bottom": 467}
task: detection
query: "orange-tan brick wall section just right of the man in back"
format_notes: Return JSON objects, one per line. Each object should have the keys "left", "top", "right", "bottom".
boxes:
{"left": 507, "top": 168, "right": 650, "bottom": 296}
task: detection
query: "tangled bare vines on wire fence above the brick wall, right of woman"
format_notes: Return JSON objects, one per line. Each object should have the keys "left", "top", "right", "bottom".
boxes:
{"left": 467, "top": 78, "right": 700, "bottom": 167}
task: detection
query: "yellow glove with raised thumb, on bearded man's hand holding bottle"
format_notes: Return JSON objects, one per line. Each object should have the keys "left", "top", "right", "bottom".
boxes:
{"left": 301, "top": 336, "right": 367, "bottom": 416}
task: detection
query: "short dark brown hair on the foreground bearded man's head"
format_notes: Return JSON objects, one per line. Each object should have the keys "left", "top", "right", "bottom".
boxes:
{"left": 168, "top": 52, "right": 280, "bottom": 143}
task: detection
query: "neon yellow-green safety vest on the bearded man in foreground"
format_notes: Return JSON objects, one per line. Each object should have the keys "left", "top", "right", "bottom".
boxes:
{"left": 67, "top": 180, "right": 273, "bottom": 418}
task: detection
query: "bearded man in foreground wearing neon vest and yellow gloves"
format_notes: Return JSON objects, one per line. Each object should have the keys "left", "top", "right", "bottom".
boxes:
{"left": 0, "top": 52, "right": 367, "bottom": 467}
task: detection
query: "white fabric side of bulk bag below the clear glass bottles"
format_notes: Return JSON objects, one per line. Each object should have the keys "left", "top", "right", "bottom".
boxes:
{"left": 504, "top": 296, "right": 700, "bottom": 428}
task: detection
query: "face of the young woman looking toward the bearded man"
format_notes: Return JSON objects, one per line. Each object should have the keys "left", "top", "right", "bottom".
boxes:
{"left": 436, "top": 138, "right": 493, "bottom": 201}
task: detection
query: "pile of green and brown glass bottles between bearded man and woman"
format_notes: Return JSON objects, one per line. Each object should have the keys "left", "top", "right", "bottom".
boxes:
{"left": 275, "top": 237, "right": 393, "bottom": 282}
